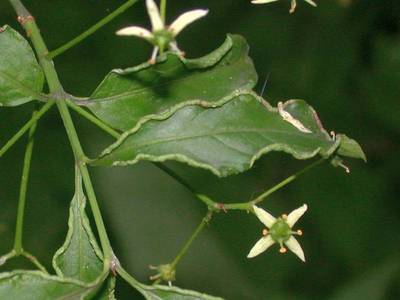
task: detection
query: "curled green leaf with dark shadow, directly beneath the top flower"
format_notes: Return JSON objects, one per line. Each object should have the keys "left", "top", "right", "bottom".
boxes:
{"left": 88, "top": 35, "right": 257, "bottom": 130}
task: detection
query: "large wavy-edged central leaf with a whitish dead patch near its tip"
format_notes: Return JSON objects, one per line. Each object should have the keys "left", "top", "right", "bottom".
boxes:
{"left": 93, "top": 91, "right": 362, "bottom": 177}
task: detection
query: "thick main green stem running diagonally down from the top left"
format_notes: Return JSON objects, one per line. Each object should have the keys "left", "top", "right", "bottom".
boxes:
{"left": 9, "top": 0, "right": 112, "bottom": 269}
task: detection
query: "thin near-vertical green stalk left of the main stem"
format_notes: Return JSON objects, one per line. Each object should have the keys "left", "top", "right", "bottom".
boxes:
{"left": 14, "top": 106, "right": 37, "bottom": 255}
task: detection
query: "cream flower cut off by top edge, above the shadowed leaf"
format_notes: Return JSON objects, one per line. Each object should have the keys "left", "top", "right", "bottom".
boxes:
{"left": 116, "top": 0, "right": 208, "bottom": 63}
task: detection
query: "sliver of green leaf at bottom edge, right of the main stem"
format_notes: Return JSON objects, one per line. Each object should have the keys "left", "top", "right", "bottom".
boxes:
{"left": 136, "top": 285, "right": 223, "bottom": 300}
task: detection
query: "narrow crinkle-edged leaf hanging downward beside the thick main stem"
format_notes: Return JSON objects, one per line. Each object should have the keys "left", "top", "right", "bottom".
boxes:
{"left": 53, "top": 170, "right": 103, "bottom": 282}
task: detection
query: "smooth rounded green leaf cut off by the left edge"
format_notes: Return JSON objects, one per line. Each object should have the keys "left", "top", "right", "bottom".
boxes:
{"left": 0, "top": 26, "right": 44, "bottom": 106}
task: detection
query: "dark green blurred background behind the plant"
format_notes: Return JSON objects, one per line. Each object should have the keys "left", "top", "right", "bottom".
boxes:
{"left": 0, "top": 0, "right": 400, "bottom": 300}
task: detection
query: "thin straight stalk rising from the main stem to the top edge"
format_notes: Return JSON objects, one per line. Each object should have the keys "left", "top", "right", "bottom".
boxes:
{"left": 47, "top": 0, "right": 138, "bottom": 59}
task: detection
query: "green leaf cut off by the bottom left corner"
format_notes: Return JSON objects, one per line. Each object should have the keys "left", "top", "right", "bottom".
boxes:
{"left": 0, "top": 271, "right": 97, "bottom": 300}
